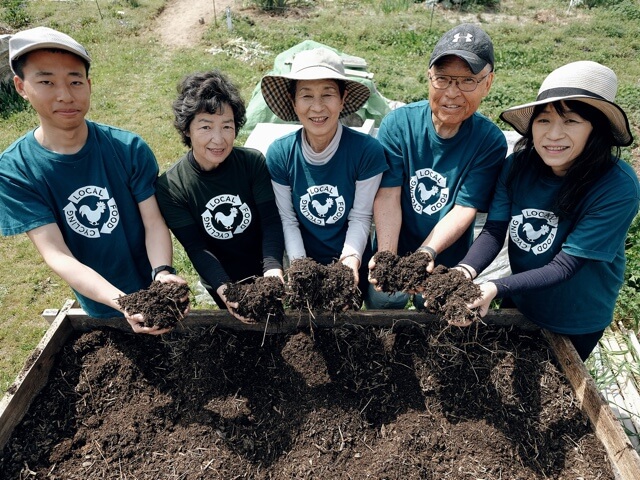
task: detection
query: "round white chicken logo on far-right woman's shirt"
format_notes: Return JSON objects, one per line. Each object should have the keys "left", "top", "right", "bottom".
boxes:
{"left": 509, "top": 208, "right": 558, "bottom": 255}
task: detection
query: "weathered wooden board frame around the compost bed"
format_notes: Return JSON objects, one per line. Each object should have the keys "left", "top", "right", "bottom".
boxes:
{"left": 0, "top": 301, "right": 640, "bottom": 480}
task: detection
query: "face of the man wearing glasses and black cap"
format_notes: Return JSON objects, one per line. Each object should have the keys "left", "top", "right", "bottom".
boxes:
{"left": 429, "top": 56, "right": 494, "bottom": 138}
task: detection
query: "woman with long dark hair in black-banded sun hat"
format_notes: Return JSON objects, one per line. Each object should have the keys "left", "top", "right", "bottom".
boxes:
{"left": 458, "top": 61, "right": 640, "bottom": 360}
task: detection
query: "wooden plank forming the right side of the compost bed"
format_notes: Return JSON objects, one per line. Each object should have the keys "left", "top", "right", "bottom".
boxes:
{"left": 543, "top": 330, "right": 640, "bottom": 480}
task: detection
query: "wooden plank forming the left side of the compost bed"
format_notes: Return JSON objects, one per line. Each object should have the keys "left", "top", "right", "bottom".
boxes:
{"left": 0, "top": 300, "right": 73, "bottom": 450}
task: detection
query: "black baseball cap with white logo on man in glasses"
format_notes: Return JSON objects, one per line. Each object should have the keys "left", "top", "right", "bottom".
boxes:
{"left": 429, "top": 23, "right": 494, "bottom": 74}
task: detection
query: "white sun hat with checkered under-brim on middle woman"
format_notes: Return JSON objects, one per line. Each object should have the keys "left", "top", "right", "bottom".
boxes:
{"left": 260, "top": 48, "right": 371, "bottom": 122}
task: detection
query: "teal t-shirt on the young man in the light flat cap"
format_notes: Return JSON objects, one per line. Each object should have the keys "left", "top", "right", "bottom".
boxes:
{"left": 0, "top": 121, "right": 158, "bottom": 318}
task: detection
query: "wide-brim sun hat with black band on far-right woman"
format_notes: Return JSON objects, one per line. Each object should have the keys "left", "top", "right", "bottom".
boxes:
{"left": 500, "top": 60, "right": 633, "bottom": 147}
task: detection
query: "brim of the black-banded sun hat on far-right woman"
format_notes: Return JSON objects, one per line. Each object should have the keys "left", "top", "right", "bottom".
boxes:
{"left": 500, "top": 95, "right": 633, "bottom": 147}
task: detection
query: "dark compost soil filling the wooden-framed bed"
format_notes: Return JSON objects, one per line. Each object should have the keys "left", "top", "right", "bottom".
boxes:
{"left": 0, "top": 322, "right": 613, "bottom": 480}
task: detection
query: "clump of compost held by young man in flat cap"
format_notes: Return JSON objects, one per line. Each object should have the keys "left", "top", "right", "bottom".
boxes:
{"left": 116, "top": 281, "right": 190, "bottom": 328}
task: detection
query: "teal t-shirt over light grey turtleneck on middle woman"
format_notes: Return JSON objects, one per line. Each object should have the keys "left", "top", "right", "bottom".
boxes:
{"left": 266, "top": 128, "right": 387, "bottom": 264}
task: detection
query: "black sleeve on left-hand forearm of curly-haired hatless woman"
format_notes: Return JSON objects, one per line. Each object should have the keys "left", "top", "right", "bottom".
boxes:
{"left": 172, "top": 225, "right": 231, "bottom": 290}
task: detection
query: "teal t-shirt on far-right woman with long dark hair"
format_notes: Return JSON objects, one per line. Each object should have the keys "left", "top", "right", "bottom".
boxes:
{"left": 488, "top": 155, "right": 640, "bottom": 334}
